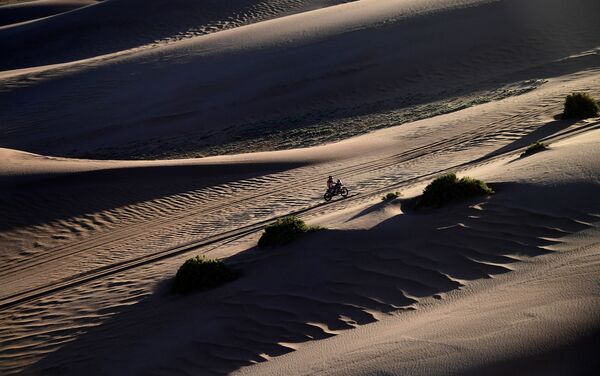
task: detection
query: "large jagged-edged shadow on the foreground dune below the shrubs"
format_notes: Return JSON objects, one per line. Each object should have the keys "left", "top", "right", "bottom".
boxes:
{"left": 26, "top": 184, "right": 600, "bottom": 375}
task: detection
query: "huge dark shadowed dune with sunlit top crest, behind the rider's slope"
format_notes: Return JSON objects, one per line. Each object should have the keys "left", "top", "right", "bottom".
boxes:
{"left": 0, "top": 0, "right": 600, "bottom": 158}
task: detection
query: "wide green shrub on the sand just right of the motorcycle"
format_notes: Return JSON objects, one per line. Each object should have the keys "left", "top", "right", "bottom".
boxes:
{"left": 417, "top": 173, "right": 494, "bottom": 207}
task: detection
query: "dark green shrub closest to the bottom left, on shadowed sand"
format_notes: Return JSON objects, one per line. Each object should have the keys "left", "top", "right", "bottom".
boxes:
{"left": 172, "top": 256, "right": 236, "bottom": 293}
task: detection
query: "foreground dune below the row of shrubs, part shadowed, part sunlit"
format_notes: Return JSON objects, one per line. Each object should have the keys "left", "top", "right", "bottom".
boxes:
{"left": 10, "top": 112, "right": 600, "bottom": 375}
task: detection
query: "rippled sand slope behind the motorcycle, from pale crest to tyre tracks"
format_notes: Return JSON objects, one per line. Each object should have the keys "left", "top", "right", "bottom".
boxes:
{"left": 0, "top": 67, "right": 600, "bottom": 291}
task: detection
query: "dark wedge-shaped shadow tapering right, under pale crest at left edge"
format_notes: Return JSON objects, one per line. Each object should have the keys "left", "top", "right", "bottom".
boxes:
{"left": 0, "top": 163, "right": 302, "bottom": 231}
